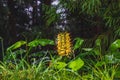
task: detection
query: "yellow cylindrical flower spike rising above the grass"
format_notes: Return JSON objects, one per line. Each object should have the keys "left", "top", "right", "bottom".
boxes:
{"left": 57, "top": 32, "right": 72, "bottom": 56}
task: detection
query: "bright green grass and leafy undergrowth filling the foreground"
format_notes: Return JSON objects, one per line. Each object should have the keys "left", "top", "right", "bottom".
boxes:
{"left": 0, "top": 38, "right": 120, "bottom": 80}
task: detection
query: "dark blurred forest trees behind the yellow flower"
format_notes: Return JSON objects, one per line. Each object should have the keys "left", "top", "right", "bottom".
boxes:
{"left": 0, "top": 0, "right": 120, "bottom": 53}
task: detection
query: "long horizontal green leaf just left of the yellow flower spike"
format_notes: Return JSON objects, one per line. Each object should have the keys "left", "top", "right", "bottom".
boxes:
{"left": 28, "top": 39, "right": 54, "bottom": 47}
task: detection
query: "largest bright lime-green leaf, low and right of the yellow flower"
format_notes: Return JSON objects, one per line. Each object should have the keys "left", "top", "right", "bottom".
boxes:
{"left": 68, "top": 58, "right": 84, "bottom": 71}
